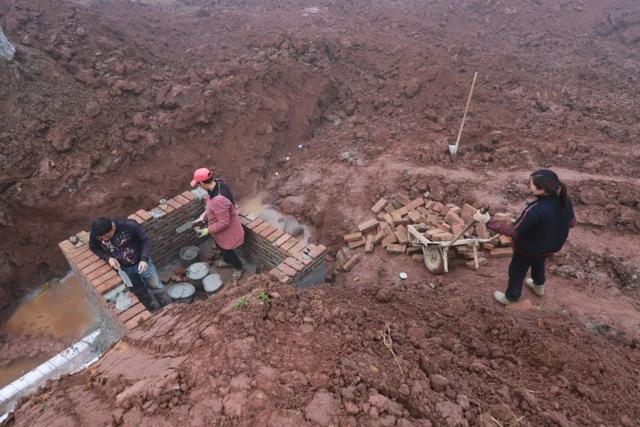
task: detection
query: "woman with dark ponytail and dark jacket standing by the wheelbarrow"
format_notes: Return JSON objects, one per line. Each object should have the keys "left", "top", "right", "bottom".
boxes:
{"left": 487, "top": 169, "right": 576, "bottom": 305}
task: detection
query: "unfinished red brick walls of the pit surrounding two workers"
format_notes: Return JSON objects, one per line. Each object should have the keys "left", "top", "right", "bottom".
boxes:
{"left": 59, "top": 190, "right": 326, "bottom": 336}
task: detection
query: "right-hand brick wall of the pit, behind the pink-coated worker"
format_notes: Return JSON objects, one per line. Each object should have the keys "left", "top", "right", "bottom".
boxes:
{"left": 234, "top": 208, "right": 327, "bottom": 284}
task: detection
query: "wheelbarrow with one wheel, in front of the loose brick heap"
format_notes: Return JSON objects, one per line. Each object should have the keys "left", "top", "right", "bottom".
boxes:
{"left": 407, "top": 209, "right": 500, "bottom": 274}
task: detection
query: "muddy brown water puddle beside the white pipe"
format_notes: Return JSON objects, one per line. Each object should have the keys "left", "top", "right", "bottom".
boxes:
{"left": 0, "top": 275, "right": 96, "bottom": 387}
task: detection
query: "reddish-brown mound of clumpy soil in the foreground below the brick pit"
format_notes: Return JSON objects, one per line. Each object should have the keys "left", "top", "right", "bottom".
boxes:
{"left": 6, "top": 276, "right": 640, "bottom": 426}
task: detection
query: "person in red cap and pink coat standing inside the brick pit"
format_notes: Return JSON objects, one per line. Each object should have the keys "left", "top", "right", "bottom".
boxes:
{"left": 191, "top": 168, "right": 244, "bottom": 280}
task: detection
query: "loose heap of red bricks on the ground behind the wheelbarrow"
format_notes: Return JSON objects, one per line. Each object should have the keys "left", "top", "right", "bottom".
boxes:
{"left": 336, "top": 193, "right": 513, "bottom": 271}
